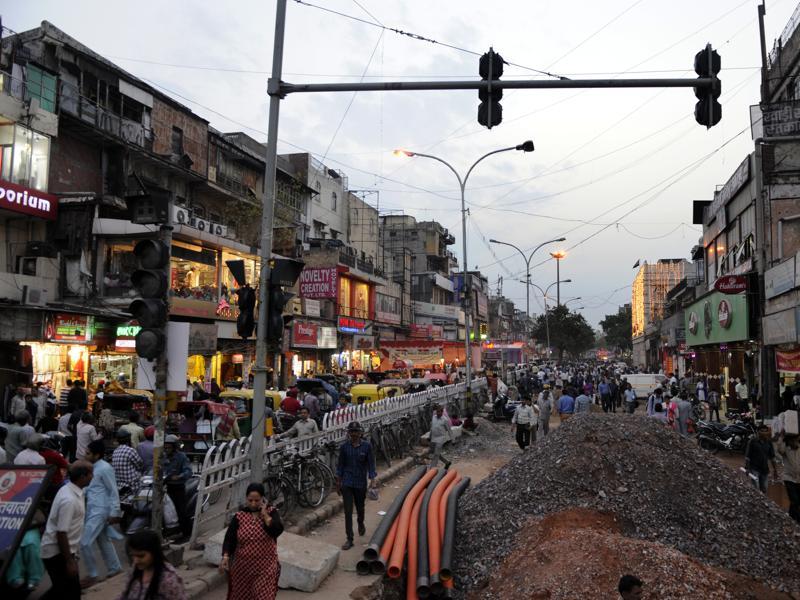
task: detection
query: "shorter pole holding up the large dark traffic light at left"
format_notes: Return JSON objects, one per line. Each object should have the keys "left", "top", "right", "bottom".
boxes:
{"left": 152, "top": 214, "right": 174, "bottom": 531}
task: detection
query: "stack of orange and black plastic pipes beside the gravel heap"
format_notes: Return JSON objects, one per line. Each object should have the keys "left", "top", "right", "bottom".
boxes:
{"left": 356, "top": 467, "right": 469, "bottom": 600}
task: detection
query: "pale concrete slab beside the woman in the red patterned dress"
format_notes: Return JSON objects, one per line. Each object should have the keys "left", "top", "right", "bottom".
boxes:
{"left": 278, "top": 532, "right": 339, "bottom": 592}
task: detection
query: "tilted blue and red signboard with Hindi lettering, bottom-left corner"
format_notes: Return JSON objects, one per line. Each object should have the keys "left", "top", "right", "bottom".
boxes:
{"left": 0, "top": 465, "right": 52, "bottom": 579}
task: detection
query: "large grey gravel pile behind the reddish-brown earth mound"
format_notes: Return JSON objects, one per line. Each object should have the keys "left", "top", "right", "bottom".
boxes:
{"left": 454, "top": 414, "right": 800, "bottom": 597}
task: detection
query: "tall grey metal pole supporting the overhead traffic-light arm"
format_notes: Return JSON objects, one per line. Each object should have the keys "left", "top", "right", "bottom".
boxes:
{"left": 250, "top": 0, "right": 286, "bottom": 482}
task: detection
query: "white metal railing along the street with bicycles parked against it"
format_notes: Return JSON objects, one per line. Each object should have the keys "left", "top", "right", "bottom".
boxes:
{"left": 190, "top": 378, "right": 486, "bottom": 545}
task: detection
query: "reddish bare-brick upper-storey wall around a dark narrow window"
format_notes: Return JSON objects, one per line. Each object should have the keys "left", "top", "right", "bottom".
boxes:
{"left": 152, "top": 98, "right": 208, "bottom": 177}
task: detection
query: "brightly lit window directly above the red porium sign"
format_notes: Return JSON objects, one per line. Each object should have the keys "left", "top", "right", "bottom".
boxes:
{"left": 0, "top": 124, "right": 50, "bottom": 191}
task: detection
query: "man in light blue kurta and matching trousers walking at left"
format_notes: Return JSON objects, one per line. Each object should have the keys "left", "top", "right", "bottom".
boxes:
{"left": 81, "top": 440, "right": 124, "bottom": 589}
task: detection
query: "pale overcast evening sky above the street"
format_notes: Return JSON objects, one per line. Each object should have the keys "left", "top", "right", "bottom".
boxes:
{"left": 2, "top": 0, "right": 800, "bottom": 326}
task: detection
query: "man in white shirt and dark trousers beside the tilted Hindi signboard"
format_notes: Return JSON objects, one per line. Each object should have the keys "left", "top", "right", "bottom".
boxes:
{"left": 41, "top": 460, "right": 94, "bottom": 600}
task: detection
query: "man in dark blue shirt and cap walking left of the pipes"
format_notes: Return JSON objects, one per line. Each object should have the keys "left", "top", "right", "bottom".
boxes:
{"left": 336, "top": 421, "right": 377, "bottom": 550}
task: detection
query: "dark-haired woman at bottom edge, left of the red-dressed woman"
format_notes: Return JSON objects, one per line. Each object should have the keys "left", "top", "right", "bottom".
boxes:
{"left": 118, "top": 529, "right": 186, "bottom": 600}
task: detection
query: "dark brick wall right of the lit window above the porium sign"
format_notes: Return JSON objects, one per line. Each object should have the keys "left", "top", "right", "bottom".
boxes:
{"left": 48, "top": 132, "right": 103, "bottom": 194}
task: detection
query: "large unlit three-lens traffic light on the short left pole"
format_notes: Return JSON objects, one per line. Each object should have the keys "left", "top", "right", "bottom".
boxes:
{"left": 128, "top": 240, "right": 169, "bottom": 360}
